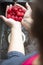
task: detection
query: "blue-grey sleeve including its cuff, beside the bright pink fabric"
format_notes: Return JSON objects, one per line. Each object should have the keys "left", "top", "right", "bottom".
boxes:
{"left": 1, "top": 51, "right": 36, "bottom": 65}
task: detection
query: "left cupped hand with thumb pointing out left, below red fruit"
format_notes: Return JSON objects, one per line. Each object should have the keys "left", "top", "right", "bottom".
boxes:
{"left": 0, "top": 5, "right": 20, "bottom": 27}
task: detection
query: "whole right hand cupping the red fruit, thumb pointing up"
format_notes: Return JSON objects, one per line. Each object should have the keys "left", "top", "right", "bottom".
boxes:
{"left": 15, "top": 3, "right": 33, "bottom": 30}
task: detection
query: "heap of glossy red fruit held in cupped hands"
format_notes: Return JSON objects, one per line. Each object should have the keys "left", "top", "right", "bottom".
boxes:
{"left": 7, "top": 5, "right": 26, "bottom": 22}
